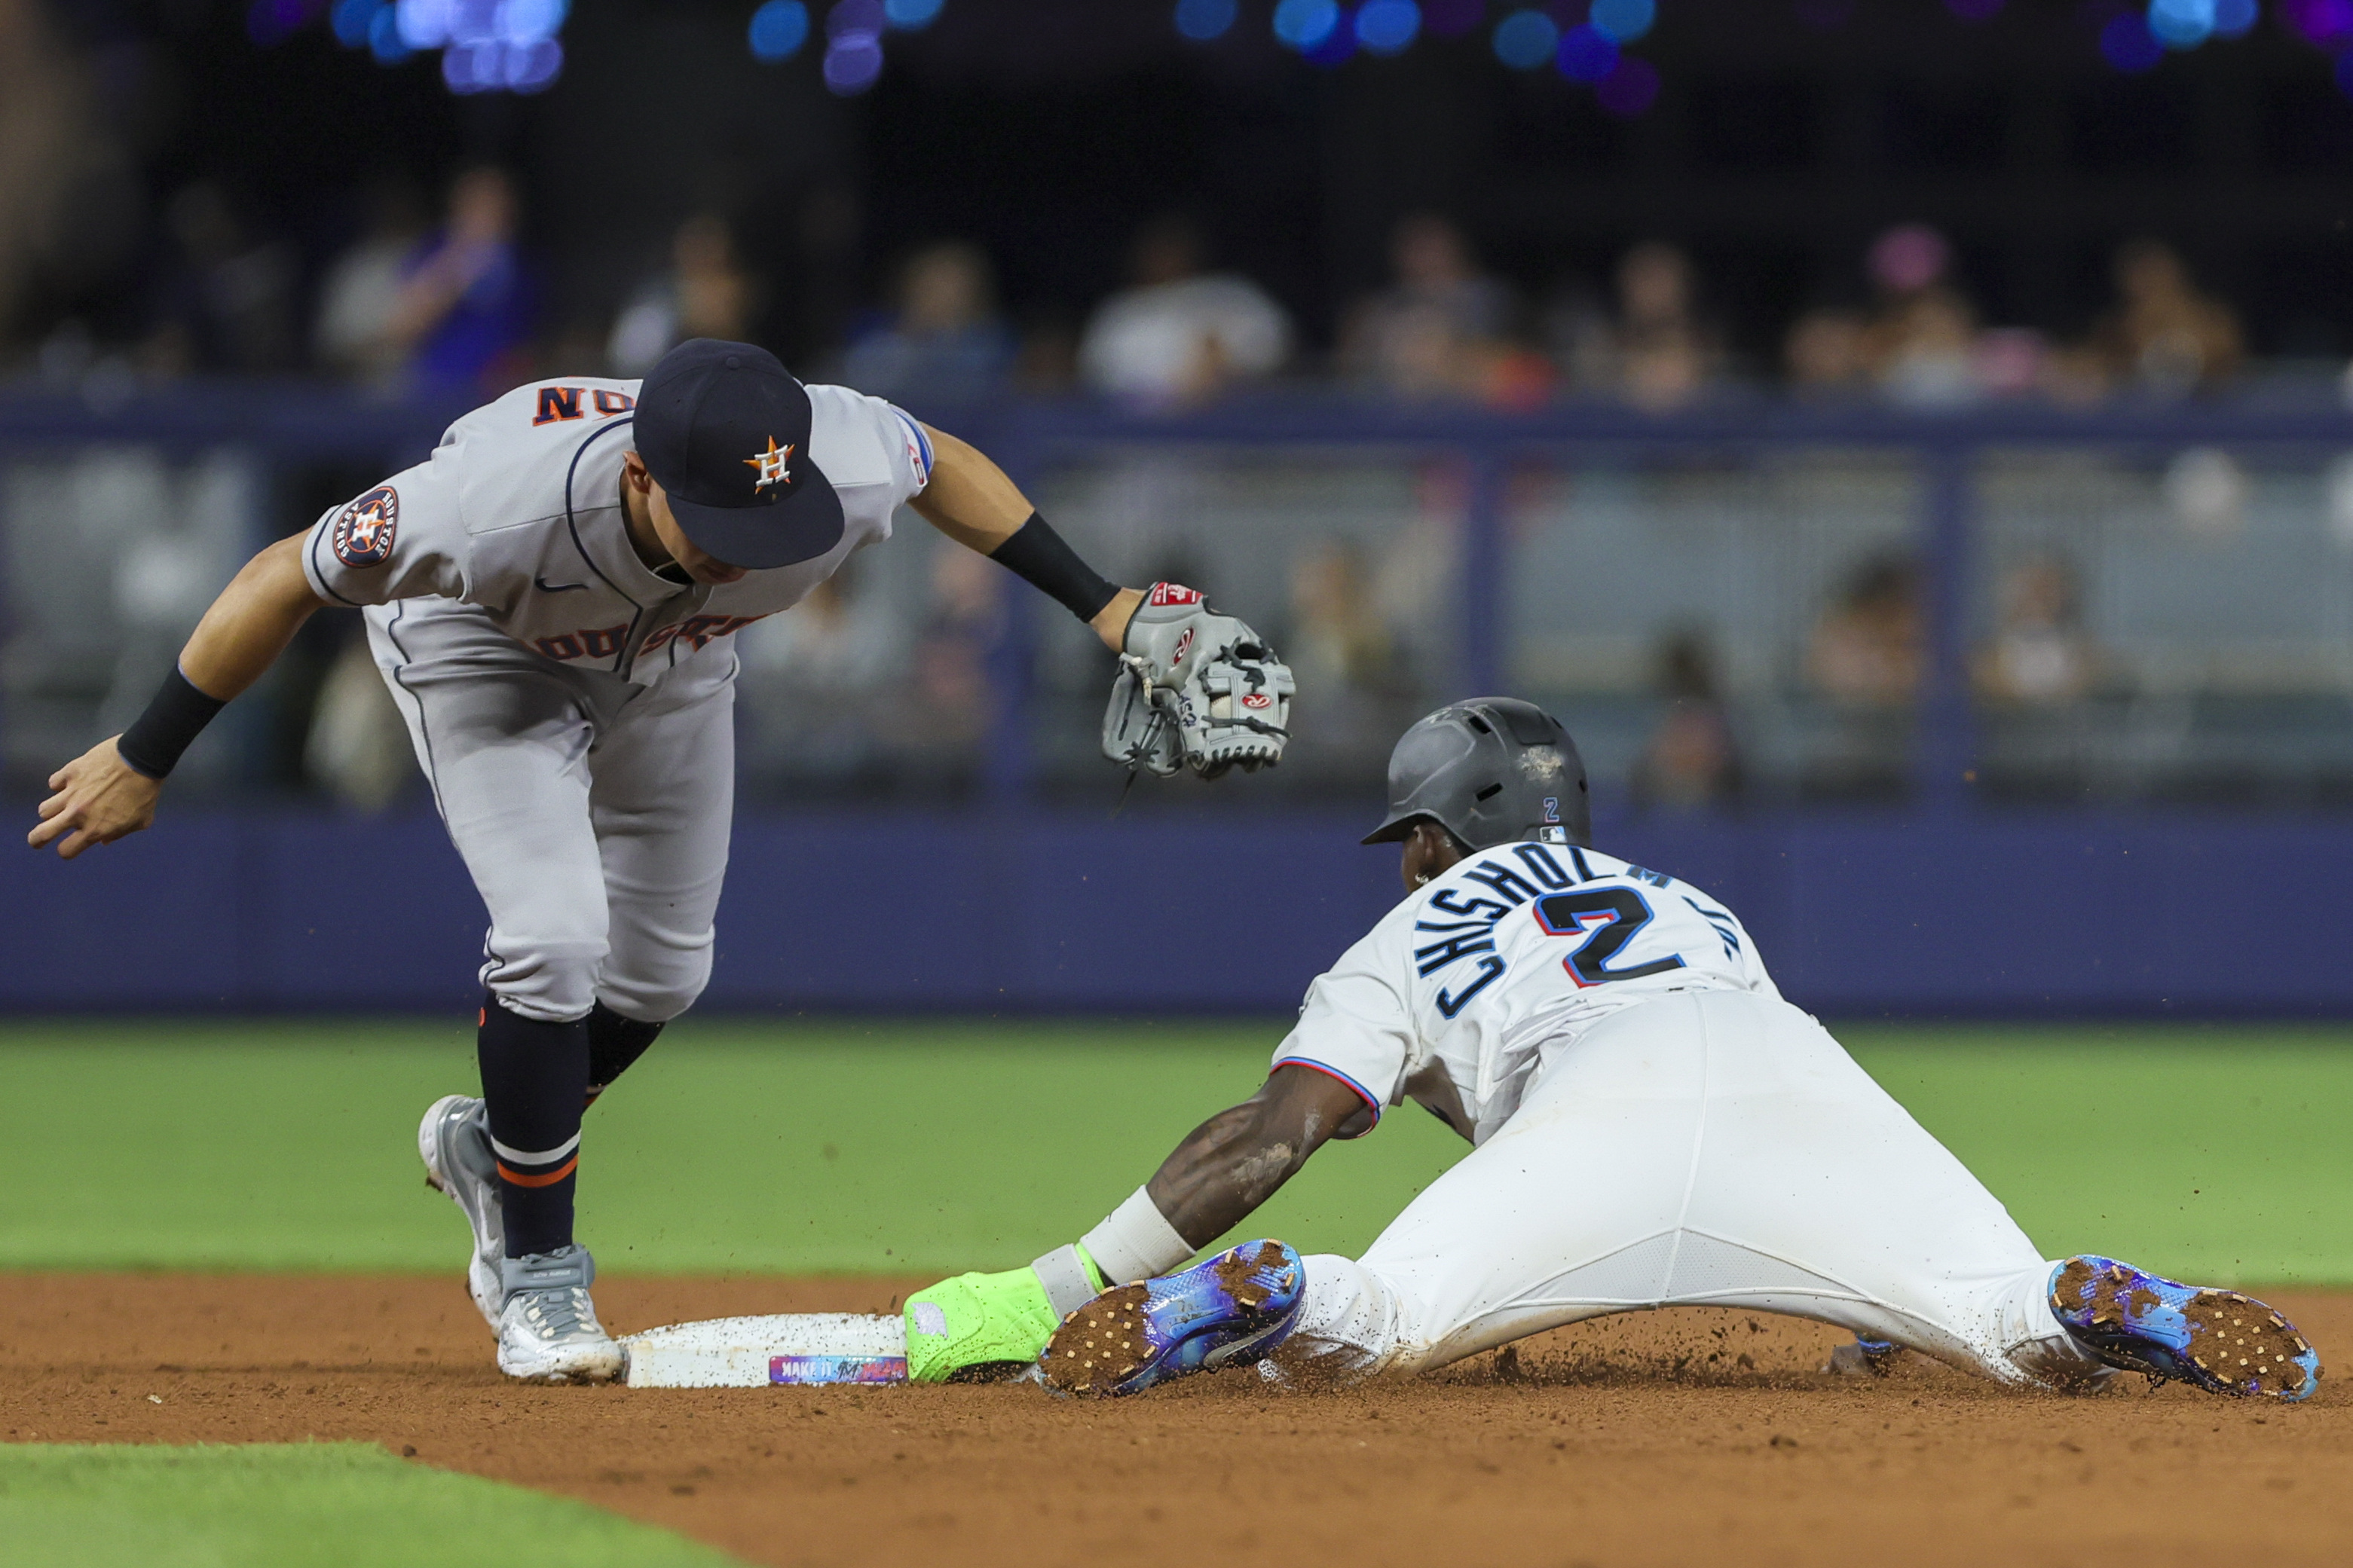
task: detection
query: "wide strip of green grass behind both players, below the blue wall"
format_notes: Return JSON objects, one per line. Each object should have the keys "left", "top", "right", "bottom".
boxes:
{"left": 0, "top": 1020, "right": 2353, "bottom": 1283}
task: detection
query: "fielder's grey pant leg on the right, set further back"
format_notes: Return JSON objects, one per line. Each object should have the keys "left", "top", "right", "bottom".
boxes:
{"left": 589, "top": 674, "right": 734, "bottom": 1022}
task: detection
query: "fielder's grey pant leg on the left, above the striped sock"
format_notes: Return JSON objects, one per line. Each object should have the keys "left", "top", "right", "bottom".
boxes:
{"left": 367, "top": 604, "right": 607, "bottom": 1022}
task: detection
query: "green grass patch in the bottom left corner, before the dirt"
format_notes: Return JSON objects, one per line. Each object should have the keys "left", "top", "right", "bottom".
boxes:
{"left": 0, "top": 1444, "right": 734, "bottom": 1568}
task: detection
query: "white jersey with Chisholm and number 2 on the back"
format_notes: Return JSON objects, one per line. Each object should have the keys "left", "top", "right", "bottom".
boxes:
{"left": 1275, "top": 844, "right": 1781, "bottom": 1142}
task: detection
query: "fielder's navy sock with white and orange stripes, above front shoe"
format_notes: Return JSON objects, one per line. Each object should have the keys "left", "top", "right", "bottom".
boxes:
{"left": 476, "top": 999, "right": 589, "bottom": 1258}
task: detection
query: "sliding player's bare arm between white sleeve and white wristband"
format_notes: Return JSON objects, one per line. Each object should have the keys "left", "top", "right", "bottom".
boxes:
{"left": 1143, "top": 1062, "right": 1372, "bottom": 1249}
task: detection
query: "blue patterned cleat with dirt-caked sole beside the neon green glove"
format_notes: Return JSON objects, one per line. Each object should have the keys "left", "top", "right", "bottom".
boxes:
{"left": 1038, "top": 1241, "right": 1306, "bottom": 1396}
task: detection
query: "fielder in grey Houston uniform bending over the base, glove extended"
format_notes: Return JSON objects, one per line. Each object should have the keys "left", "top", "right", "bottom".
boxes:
{"left": 28, "top": 338, "right": 1292, "bottom": 1383}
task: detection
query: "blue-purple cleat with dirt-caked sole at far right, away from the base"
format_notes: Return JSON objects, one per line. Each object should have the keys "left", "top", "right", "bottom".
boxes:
{"left": 2052, "top": 1255, "right": 2320, "bottom": 1398}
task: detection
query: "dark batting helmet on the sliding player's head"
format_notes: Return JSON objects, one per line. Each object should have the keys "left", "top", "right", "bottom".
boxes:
{"left": 1365, "top": 696, "right": 1593, "bottom": 848}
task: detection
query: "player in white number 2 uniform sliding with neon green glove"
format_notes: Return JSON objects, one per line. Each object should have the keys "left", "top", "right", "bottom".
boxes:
{"left": 906, "top": 698, "right": 2320, "bottom": 1398}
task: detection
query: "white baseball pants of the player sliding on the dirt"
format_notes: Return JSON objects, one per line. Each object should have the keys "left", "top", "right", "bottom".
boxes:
{"left": 1275, "top": 992, "right": 2094, "bottom": 1385}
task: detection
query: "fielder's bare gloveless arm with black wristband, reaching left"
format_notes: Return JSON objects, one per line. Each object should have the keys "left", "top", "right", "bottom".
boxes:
{"left": 26, "top": 533, "right": 323, "bottom": 860}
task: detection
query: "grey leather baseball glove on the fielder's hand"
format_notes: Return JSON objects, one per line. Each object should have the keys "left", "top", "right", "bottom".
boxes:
{"left": 1103, "top": 583, "right": 1292, "bottom": 778}
